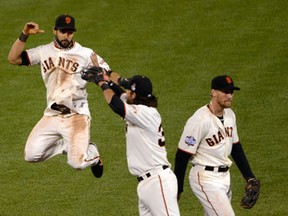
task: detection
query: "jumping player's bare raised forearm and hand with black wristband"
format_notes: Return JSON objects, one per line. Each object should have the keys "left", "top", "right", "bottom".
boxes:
{"left": 8, "top": 22, "right": 44, "bottom": 65}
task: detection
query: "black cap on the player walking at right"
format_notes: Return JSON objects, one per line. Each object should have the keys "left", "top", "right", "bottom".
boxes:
{"left": 211, "top": 75, "right": 240, "bottom": 91}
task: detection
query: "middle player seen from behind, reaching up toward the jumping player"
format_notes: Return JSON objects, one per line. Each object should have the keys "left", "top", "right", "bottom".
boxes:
{"left": 83, "top": 62, "right": 180, "bottom": 216}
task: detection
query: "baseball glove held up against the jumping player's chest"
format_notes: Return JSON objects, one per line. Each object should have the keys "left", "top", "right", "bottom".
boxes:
{"left": 81, "top": 66, "right": 105, "bottom": 84}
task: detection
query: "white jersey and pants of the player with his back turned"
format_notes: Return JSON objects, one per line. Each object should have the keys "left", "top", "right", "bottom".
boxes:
{"left": 121, "top": 94, "right": 180, "bottom": 216}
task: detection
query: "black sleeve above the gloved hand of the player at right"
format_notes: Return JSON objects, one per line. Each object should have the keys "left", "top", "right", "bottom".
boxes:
{"left": 231, "top": 142, "right": 255, "bottom": 181}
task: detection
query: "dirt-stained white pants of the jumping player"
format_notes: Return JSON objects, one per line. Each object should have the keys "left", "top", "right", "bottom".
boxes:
{"left": 25, "top": 114, "right": 99, "bottom": 169}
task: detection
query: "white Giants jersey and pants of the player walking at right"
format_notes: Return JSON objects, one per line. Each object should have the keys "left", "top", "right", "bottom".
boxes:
{"left": 178, "top": 105, "right": 239, "bottom": 216}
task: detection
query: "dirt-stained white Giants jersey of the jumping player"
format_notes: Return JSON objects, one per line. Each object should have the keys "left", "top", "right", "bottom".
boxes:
{"left": 26, "top": 42, "right": 110, "bottom": 117}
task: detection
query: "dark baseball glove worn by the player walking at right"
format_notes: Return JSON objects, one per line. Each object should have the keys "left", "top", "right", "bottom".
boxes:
{"left": 241, "top": 178, "right": 260, "bottom": 209}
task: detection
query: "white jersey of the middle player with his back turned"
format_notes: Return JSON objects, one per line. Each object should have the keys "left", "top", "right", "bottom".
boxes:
{"left": 121, "top": 94, "right": 171, "bottom": 176}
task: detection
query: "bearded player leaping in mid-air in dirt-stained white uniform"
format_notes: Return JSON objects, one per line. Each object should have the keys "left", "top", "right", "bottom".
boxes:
{"left": 8, "top": 14, "right": 110, "bottom": 177}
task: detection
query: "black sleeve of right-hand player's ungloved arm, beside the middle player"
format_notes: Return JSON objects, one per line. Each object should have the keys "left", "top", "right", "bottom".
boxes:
{"left": 174, "top": 148, "right": 192, "bottom": 194}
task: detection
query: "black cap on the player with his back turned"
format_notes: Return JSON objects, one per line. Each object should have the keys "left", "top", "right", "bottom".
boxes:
{"left": 127, "top": 75, "right": 153, "bottom": 98}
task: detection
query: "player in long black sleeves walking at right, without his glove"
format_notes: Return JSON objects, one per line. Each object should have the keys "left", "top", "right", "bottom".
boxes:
{"left": 174, "top": 75, "right": 255, "bottom": 216}
